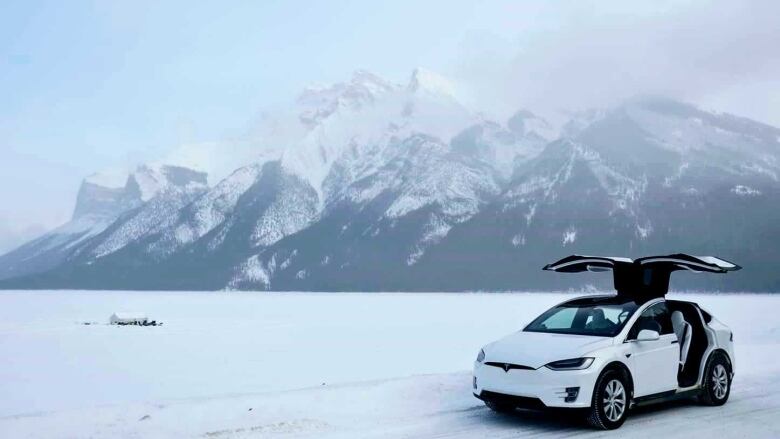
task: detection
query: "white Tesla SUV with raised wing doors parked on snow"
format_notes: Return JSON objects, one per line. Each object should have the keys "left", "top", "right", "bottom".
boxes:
{"left": 473, "top": 255, "right": 740, "bottom": 429}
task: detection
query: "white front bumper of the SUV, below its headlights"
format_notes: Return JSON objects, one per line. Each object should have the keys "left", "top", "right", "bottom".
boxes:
{"left": 473, "top": 362, "right": 599, "bottom": 408}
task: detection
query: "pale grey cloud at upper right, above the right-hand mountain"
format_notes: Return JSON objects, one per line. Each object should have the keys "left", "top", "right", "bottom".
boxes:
{"left": 456, "top": 1, "right": 780, "bottom": 125}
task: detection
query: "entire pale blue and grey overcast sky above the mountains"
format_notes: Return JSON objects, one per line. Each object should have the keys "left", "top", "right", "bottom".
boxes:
{"left": 0, "top": 0, "right": 780, "bottom": 251}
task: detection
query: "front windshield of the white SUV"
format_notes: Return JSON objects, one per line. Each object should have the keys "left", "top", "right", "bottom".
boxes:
{"left": 524, "top": 296, "right": 638, "bottom": 337}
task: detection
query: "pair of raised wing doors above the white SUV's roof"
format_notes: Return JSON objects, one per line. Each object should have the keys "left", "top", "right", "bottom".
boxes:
{"left": 542, "top": 253, "right": 742, "bottom": 299}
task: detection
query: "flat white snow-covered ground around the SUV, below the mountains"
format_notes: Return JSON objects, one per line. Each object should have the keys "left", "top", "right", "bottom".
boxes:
{"left": 0, "top": 292, "right": 780, "bottom": 438}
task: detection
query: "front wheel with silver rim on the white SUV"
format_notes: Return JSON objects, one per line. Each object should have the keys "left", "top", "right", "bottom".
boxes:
{"left": 587, "top": 369, "right": 631, "bottom": 430}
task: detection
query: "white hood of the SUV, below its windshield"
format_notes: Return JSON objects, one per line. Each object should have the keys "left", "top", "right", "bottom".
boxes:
{"left": 485, "top": 331, "right": 612, "bottom": 369}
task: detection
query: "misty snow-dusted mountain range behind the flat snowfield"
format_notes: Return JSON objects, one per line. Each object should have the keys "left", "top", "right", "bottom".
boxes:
{"left": 0, "top": 69, "right": 780, "bottom": 291}
